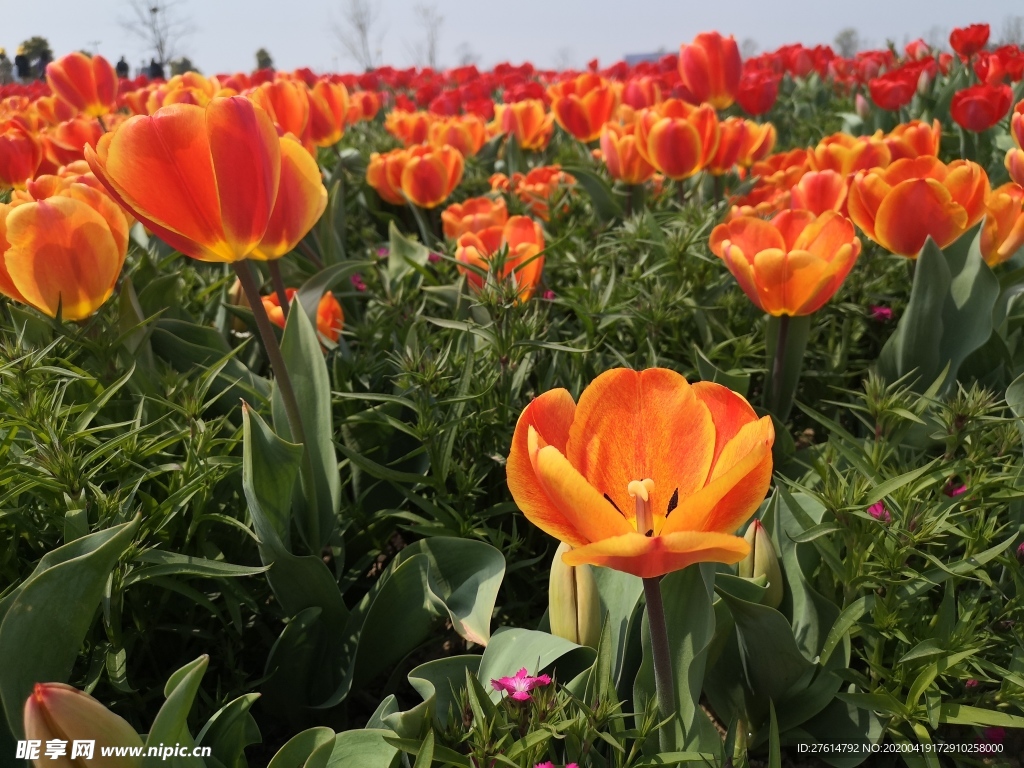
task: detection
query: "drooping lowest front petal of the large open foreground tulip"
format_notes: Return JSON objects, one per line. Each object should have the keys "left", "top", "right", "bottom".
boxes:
{"left": 562, "top": 530, "right": 751, "bottom": 579}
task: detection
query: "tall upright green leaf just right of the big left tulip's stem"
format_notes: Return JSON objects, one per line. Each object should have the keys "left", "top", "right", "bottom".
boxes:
{"left": 271, "top": 301, "right": 341, "bottom": 553}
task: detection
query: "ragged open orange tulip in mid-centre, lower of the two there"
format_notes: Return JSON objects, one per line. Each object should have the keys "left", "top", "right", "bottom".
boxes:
{"left": 455, "top": 216, "right": 544, "bottom": 302}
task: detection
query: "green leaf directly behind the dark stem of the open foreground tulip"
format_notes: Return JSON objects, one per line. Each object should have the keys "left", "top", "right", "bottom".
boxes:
{"left": 633, "top": 563, "right": 721, "bottom": 752}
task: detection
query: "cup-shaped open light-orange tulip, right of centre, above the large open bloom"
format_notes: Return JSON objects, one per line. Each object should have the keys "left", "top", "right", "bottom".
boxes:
{"left": 710, "top": 211, "right": 860, "bottom": 316}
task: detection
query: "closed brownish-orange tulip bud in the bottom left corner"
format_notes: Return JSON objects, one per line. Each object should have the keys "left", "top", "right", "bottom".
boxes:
{"left": 24, "top": 683, "right": 143, "bottom": 768}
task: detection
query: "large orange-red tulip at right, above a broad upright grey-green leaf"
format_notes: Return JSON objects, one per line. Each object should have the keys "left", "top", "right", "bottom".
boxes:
{"left": 847, "top": 155, "right": 989, "bottom": 258}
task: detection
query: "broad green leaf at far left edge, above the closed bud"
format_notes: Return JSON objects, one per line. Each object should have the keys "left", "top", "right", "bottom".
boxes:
{"left": 0, "top": 517, "right": 139, "bottom": 738}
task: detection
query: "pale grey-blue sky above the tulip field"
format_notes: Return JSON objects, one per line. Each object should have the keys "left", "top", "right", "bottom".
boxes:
{"left": 0, "top": 0, "right": 1024, "bottom": 74}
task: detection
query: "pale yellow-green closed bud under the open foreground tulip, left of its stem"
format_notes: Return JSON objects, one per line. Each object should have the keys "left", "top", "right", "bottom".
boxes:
{"left": 548, "top": 543, "right": 601, "bottom": 648}
